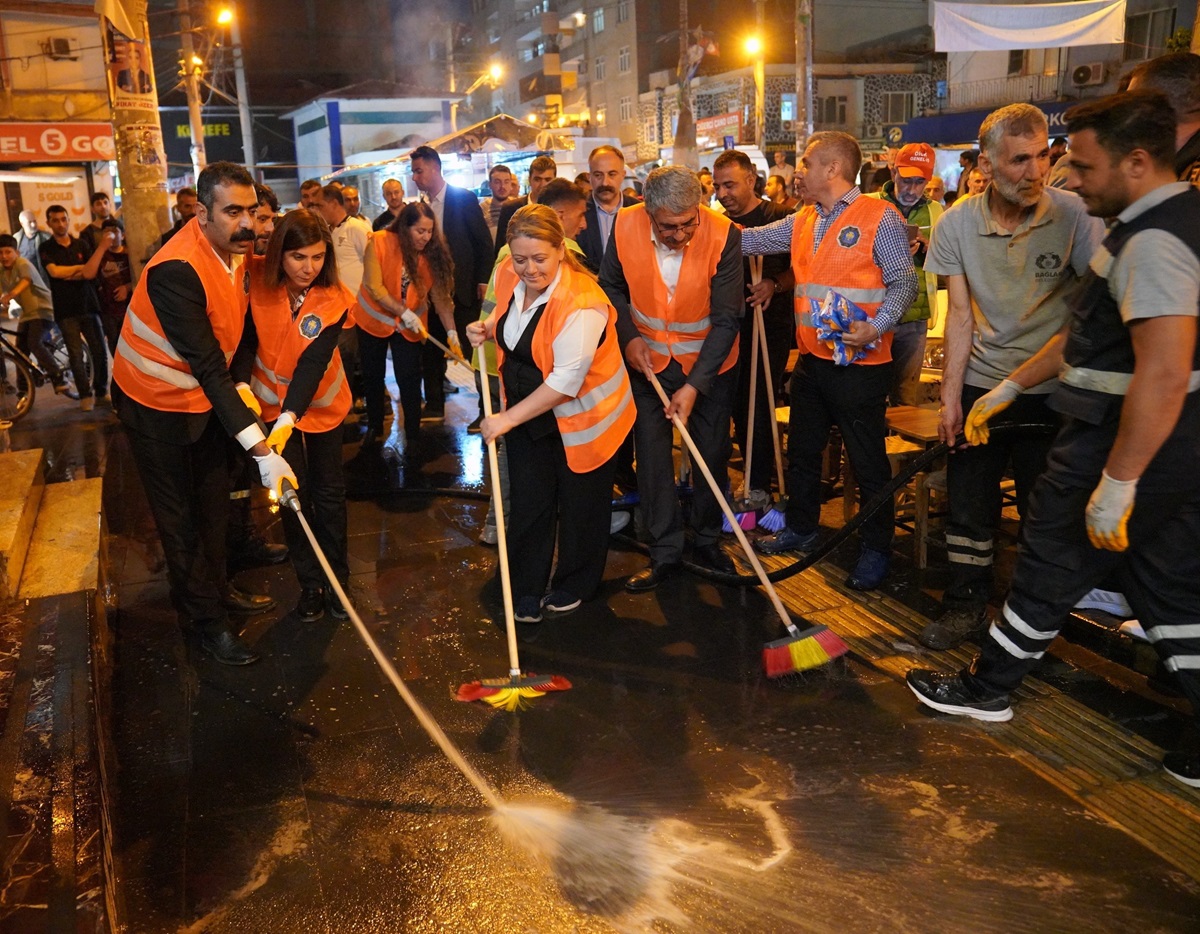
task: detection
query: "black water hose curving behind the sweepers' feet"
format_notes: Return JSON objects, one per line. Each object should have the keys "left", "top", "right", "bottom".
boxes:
{"left": 369, "top": 421, "right": 1058, "bottom": 587}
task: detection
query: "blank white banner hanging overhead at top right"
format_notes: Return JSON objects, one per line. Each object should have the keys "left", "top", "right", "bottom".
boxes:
{"left": 930, "top": 0, "right": 1126, "bottom": 52}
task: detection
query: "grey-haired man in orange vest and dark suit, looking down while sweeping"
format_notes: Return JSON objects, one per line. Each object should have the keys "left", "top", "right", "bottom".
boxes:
{"left": 600, "top": 166, "right": 744, "bottom": 585}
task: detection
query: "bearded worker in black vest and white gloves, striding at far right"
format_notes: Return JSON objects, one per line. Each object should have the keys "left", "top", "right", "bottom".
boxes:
{"left": 907, "top": 91, "right": 1200, "bottom": 788}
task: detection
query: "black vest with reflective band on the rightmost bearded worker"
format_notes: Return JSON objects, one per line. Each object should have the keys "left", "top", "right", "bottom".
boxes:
{"left": 1050, "top": 188, "right": 1200, "bottom": 424}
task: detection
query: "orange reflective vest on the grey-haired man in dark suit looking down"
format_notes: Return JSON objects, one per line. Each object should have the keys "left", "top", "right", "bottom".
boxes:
{"left": 613, "top": 204, "right": 739, "bottom": 373}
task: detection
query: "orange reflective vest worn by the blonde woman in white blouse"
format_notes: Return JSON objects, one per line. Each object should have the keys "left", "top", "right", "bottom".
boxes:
{"left": 496, "top": 258, "right": 636, "bottom": 473}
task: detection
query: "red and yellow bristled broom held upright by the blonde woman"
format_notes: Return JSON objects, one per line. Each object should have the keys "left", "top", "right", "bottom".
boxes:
{"left": 456, "top": 339, "right": 571, "bottom": 711}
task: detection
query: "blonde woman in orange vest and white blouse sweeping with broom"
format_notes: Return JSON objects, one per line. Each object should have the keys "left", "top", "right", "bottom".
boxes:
{"left": 467, "top": 204, "right": 635, "bottom": 623}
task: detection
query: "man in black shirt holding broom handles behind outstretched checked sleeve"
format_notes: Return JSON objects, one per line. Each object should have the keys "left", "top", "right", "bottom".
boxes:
{"left": 713, "top": 149, "right": 796, "bottom": 498}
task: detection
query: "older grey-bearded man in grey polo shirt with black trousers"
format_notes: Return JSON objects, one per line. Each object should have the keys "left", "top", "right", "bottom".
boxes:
{"left": 919, "top": 103, "right": 1104, "bottom": 649}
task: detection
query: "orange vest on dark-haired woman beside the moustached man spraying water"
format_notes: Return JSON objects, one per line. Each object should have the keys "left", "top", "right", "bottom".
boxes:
{"left": 250, "top": 257, "right": 354, "bottom": 432}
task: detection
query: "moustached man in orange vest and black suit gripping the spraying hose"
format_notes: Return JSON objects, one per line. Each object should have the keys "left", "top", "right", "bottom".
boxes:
{"left": 113, "top": 162, "right": 296, "bottom": 665}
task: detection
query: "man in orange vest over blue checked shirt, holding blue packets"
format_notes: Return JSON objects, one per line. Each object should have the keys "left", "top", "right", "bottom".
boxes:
{"left": 743, "top": 132, "right": 918, "bottom": 591}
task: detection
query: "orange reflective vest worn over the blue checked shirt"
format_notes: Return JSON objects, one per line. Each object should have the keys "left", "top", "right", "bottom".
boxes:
{"left": 792, "top": 197, "right": 895, "bottom": 364}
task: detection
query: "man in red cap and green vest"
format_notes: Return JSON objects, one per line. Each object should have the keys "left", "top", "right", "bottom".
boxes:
{"left": 866, "top": 143, "right": 944, "bottom": 406}
